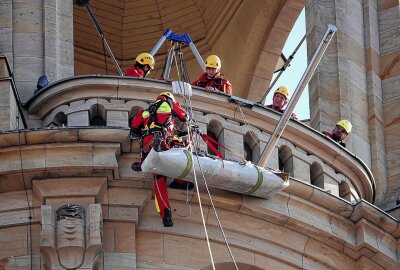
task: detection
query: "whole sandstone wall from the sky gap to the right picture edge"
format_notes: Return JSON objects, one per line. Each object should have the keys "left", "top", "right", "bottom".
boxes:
{"left": 306, "top": 0, "right": 400, "bottom": 207}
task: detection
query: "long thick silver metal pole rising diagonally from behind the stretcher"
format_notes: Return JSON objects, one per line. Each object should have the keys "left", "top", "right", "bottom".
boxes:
{"left": 257, "top": 24, "right": 337, "bottom": 167}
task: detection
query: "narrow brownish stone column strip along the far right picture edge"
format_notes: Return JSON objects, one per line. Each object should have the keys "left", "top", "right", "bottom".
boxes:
{"left": 376, "top": 0, "right": 400, "bottom": 209}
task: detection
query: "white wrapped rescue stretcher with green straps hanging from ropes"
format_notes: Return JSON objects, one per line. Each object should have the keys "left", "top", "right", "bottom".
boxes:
{"left": 141, "top": 148, "right": 289, "bottom": 199}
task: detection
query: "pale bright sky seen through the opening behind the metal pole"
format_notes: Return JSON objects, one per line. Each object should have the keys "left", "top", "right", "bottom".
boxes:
{"left": 266, "top": 9, "right": 310, "bottom": 120}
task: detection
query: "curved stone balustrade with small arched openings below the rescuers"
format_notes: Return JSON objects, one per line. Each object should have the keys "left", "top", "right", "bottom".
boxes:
{"left": 26, "top": 75, "right": 374, "bottom": 202}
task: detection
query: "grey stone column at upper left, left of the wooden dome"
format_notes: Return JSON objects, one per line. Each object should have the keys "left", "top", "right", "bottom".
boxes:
{"left": 0, "top": 0, "right": 74, "bottom": 102}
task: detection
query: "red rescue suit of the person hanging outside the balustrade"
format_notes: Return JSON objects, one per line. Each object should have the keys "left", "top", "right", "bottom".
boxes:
{"left": 132, "top": 96, "right": 187, "bottom": 219}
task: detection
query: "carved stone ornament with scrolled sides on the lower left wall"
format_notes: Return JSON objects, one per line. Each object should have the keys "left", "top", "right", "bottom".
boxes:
{"left": 40, "top": 204, "right": 102, "bottom": 269}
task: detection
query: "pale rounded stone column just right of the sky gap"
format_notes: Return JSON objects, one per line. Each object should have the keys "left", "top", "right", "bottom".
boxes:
{"left": 305, "top": 0, "right": 379, "bottom": 195}
